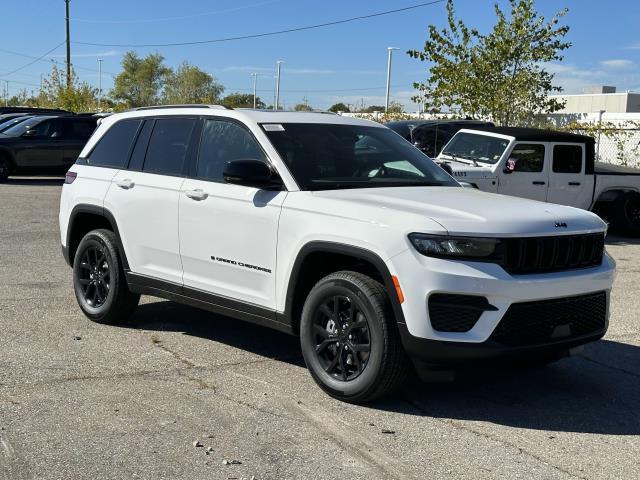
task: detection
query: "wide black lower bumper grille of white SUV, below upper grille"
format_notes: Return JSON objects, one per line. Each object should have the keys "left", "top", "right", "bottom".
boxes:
{"left": 491, "top": 292, "right": 607, "bottom": 347}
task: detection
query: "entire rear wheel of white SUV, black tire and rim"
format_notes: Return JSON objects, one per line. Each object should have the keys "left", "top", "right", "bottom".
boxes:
{"left": 73, "top": 229, "right": 140, "bottom": 325}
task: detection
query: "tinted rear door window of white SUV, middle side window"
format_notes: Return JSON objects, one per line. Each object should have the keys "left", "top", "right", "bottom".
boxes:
{"left": 142, "top": 118, "right": 196, "bottom": 175}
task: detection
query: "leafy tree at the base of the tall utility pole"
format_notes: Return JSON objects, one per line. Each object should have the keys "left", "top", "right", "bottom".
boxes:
{"left": 33, "top": 65, "right": 98, "bottom": 112}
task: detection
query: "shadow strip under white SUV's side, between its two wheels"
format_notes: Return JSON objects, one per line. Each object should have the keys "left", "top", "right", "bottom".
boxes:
{"left": 122, "top": 301, "right": 304, "bottom": 366}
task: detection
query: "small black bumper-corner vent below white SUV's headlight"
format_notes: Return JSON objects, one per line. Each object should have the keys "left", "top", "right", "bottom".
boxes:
{"left": 429, "top": 293, "right": 496, "bottom": 332}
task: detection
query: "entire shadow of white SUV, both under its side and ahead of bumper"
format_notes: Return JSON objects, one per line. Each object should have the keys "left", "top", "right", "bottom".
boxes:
{"left": 123, "top": 301, "right": 640, "bottom": 435}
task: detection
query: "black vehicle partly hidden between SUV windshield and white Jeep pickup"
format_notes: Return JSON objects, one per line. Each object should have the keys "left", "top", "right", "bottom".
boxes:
{"left": 385, "top": 120, "right": 494, "bottom": 158}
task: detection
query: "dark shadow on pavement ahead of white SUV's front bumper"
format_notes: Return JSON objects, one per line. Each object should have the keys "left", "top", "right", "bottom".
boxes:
{"left": 374, "top": 340, "right": 640, "bottom": 435}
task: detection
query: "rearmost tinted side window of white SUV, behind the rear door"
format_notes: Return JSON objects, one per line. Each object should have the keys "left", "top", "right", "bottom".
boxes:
{"left": 87, "top": 120, "right": 141, "bottom": 168}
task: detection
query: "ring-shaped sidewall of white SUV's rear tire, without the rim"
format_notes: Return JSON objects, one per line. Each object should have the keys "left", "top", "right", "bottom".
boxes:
{"left": 73, "top": 232, "right": 120, "bottom": 320}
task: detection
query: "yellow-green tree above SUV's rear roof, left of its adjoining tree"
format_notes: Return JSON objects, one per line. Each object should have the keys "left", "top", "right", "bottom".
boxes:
{"left": 111, "top": 51, "right": 172, "bottom": 108}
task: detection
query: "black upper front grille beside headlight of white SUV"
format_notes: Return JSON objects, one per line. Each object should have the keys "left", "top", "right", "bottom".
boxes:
{"left": 502, "top": 233, "right": 604, "bottom": 275}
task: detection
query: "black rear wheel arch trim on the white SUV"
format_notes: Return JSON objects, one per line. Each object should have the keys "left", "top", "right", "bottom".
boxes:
{"left": 66, "top": 204, "right": 129, "bottom": 271}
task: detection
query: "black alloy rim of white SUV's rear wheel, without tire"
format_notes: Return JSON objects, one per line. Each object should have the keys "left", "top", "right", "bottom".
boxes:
{"left": 78, "top": 245, "right": 111, "bottom": 308}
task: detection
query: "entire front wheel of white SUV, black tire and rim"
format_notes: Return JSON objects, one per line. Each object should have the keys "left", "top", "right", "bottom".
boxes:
{"left": 300, "top": 271, "right": 409, "bottom": 403}
